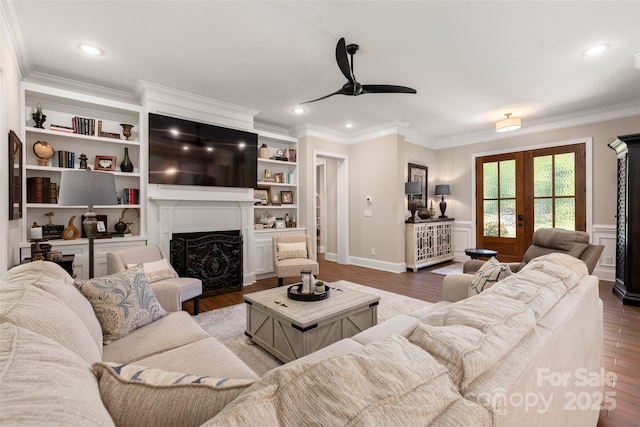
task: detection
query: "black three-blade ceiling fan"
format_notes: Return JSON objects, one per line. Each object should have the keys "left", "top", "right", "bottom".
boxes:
{"left": 302, "top": 37, "right": 417, "bottom": 104}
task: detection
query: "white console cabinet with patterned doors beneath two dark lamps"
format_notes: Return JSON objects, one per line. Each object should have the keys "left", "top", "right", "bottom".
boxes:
{"left": 404, "top": 218, "right": 455, "bottom": 271}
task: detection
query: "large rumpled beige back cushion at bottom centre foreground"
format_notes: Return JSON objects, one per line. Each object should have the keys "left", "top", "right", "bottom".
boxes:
{"left": 204, "top": 335, "right": 470, "bottom": 426}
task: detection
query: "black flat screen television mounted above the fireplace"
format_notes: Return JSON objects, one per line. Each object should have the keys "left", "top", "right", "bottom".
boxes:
{"left": 149, "top": 113, "right": 258, "bottom": 188}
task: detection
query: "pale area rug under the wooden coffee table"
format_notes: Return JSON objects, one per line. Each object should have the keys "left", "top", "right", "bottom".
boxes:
{"left": 194, "top": 281, "right": 430, "bottom": 375}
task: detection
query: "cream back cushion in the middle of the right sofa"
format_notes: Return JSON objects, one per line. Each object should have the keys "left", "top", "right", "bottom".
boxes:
{"left": 407, "top": 293, "right": 536, "bottom": 390}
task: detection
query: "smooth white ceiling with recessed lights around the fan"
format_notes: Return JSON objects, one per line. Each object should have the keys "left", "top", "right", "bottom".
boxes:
{"left": 2, "top": 0, "right": 640, "bottom": 147}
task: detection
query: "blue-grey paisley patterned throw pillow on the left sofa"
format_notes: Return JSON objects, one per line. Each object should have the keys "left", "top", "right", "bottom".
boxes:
{"left": 75, "top": 267, "right": 167, "bottom": 344}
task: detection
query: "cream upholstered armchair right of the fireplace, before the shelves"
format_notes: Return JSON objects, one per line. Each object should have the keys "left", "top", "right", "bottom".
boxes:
{"left": 273, "top": 233, "right": 320, "bottom": 286}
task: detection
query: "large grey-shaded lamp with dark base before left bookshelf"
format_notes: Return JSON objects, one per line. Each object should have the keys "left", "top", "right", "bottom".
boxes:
{"left": 58, "top": 168, "right": 118, "bottom": 279}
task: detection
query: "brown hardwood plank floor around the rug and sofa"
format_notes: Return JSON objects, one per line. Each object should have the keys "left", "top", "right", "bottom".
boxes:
{"left": 184, "top": 257, "right": 640, "bottom": 427}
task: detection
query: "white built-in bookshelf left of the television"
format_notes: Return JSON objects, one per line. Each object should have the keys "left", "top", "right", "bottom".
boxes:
{"left": 20, "top": 82, "right": 146, "bottom": 276}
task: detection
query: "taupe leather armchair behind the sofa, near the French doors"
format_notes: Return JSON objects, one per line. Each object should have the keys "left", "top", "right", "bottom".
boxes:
{"left": 462, "top": 228, "right": 604, "bottom": 274}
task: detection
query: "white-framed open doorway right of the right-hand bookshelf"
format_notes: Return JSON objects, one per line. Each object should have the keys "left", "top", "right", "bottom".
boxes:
{"left": 307, "top": 150, "right": 349, "bottom": 264}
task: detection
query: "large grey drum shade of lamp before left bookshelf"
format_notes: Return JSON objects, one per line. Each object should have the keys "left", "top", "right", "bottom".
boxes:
{"left": 58, "top": 169, "right": 118, "bottom": 206}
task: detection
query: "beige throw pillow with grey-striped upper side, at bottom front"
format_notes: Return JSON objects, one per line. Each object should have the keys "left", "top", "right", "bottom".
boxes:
{"left": 93, "top": 363, "right": 254, "bottom": 427}
